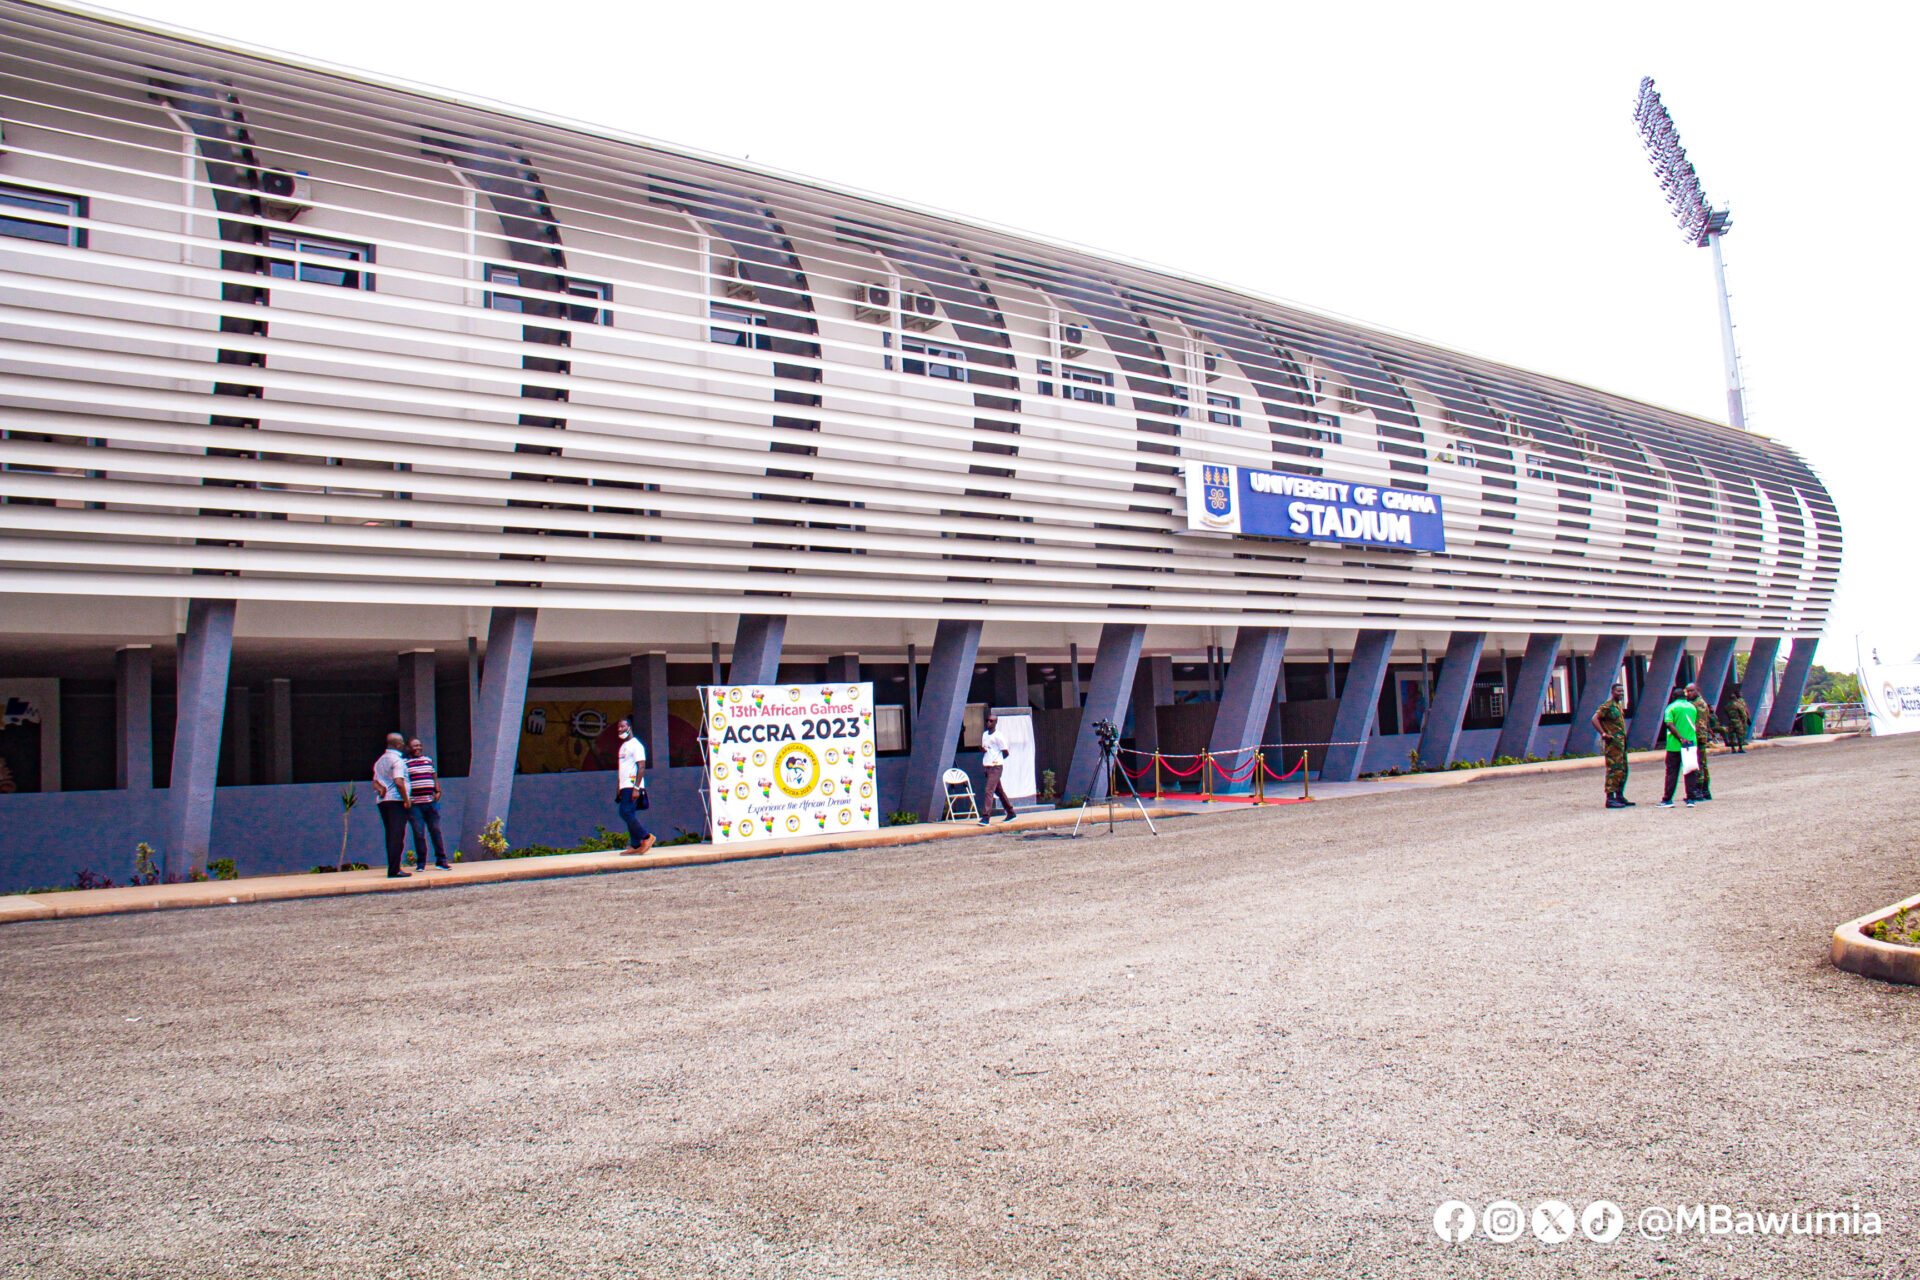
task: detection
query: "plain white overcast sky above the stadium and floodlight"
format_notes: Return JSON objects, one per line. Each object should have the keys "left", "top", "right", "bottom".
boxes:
{"left": 86, "top": 0, "right": 1920, "bottom": 668}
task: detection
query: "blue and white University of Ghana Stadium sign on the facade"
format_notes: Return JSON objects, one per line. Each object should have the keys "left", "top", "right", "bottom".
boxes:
{"left": 1187, "top": 462, "right": 1446, "bottom": 551}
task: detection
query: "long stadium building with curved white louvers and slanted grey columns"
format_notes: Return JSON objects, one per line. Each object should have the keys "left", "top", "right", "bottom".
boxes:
{"left": 0, "top": 0, "right": 1841, "bottom": 889}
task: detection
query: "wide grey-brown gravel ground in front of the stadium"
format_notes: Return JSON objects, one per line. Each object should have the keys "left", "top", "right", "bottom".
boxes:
{"left": 0, "top": 739, "right": 1920, "bottom": 1280}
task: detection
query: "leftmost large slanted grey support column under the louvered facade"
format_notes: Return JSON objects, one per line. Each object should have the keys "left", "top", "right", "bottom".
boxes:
{"left": 161, "top": 601, "right": 234, "bottom": 879}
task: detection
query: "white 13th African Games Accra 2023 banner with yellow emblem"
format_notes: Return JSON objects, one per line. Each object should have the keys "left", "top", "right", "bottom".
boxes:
{"left": 705, "top": 685, "right": 879, "bottom": 844}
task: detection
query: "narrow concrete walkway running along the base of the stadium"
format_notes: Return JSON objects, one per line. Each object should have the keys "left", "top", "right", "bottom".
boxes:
{"left": 0, "top": 733, "right": 1851, "bottom": 925}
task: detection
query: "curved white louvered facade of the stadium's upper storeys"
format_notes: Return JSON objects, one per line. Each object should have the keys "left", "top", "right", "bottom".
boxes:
{"left": 0, "top": 4, "right": 1841, "bottom": 647}
